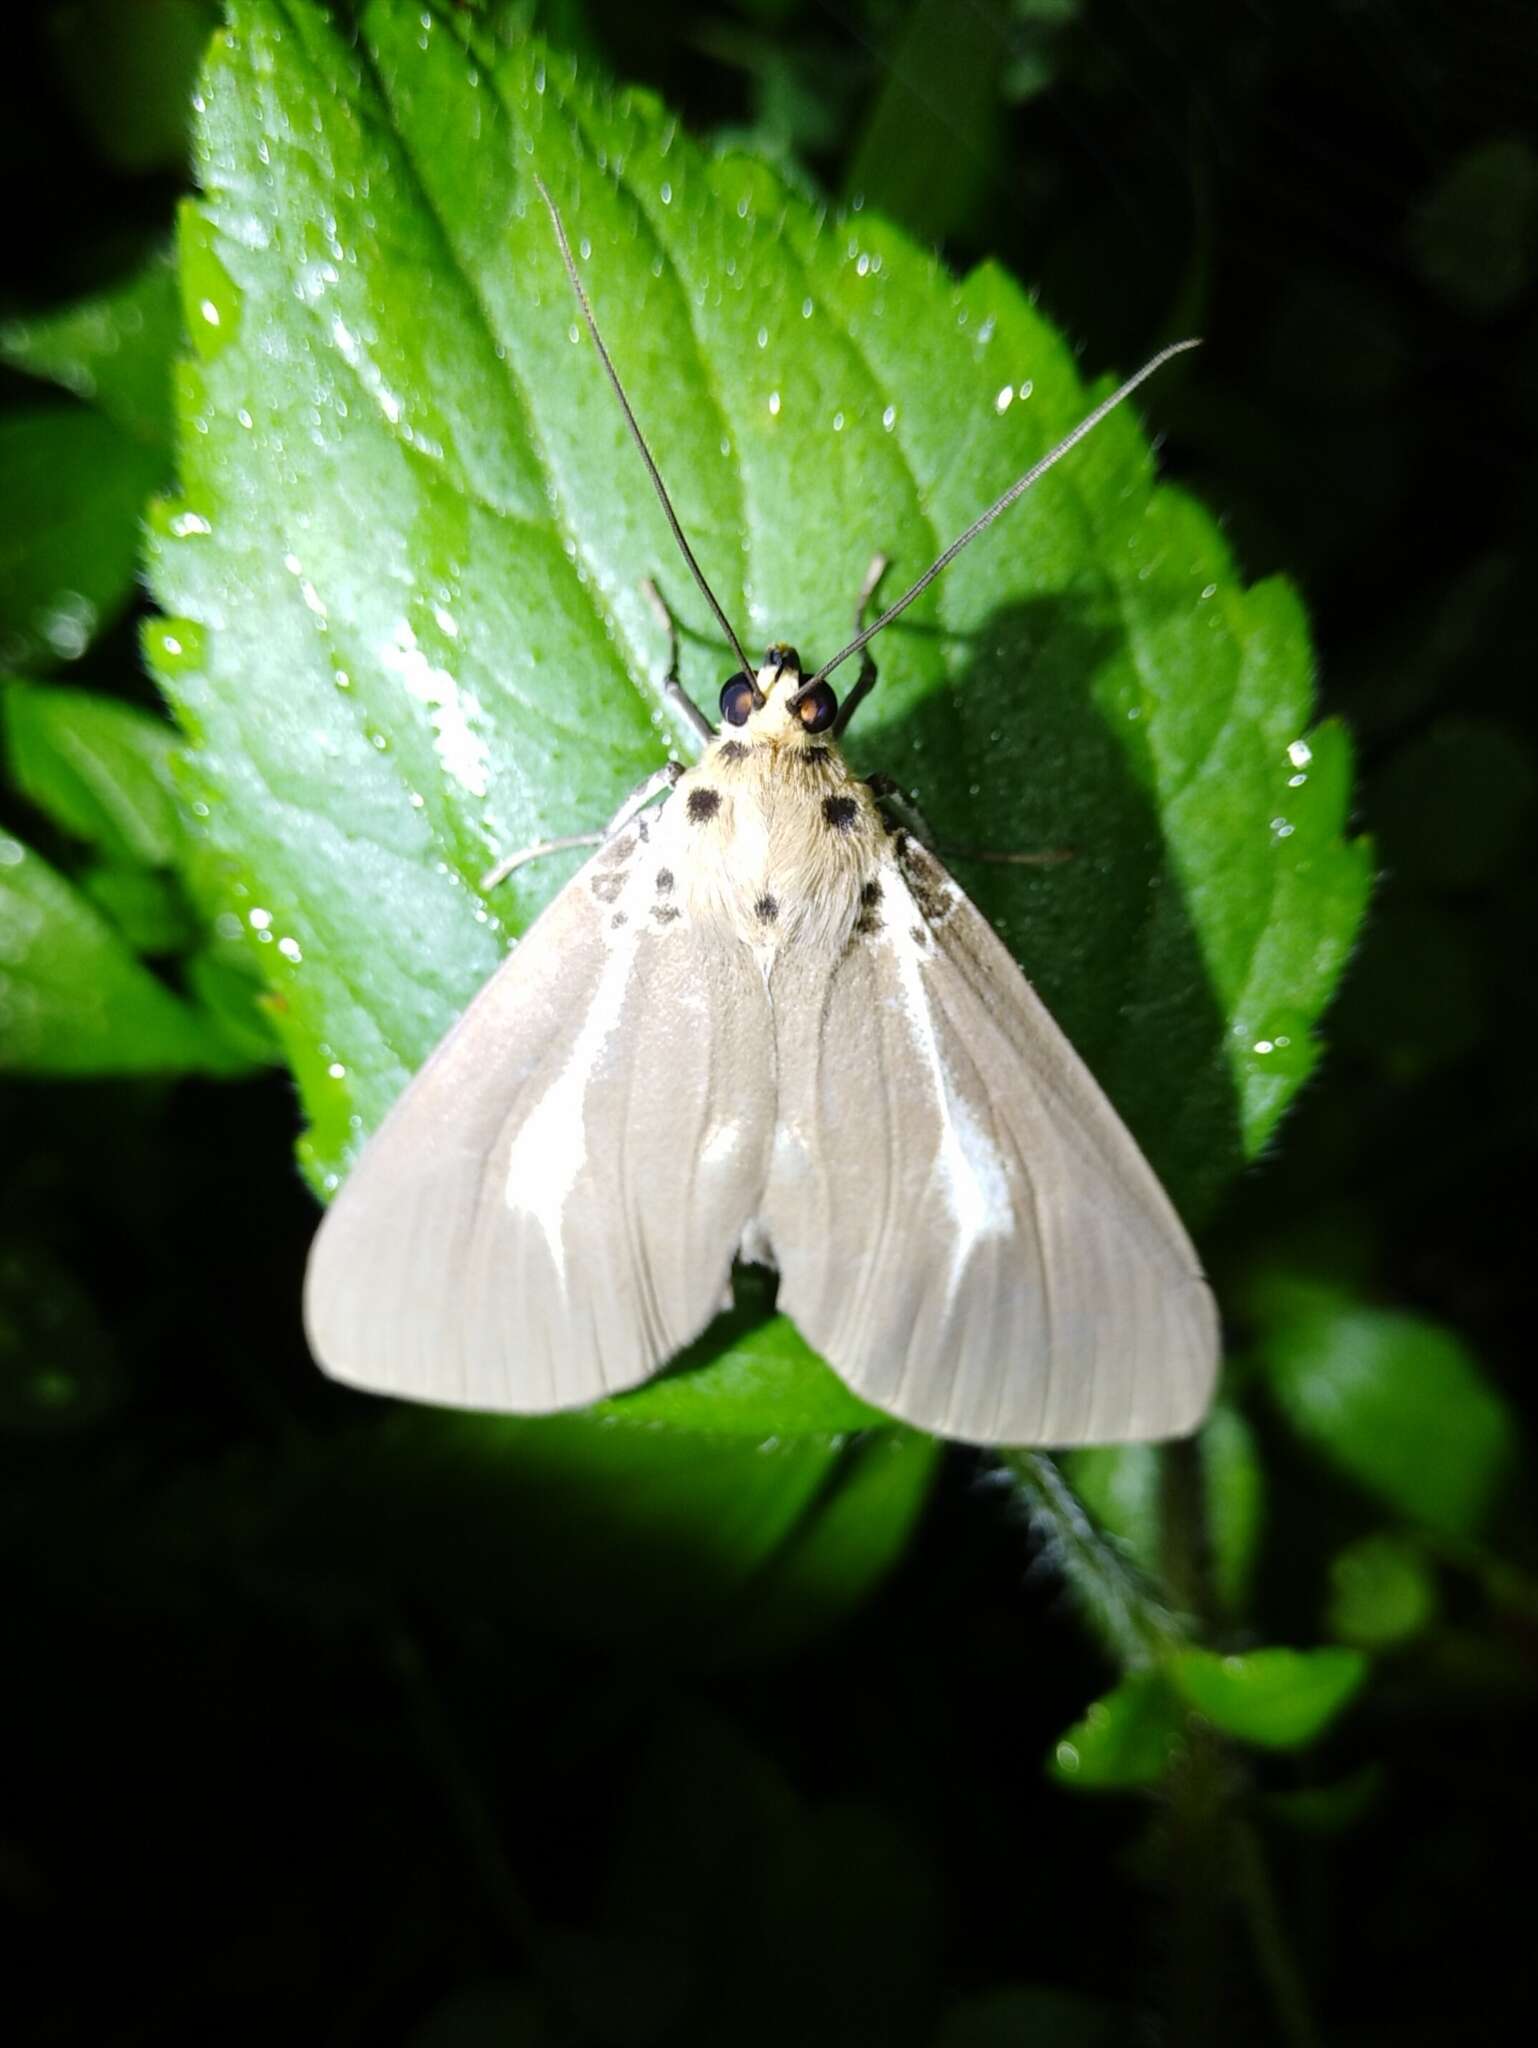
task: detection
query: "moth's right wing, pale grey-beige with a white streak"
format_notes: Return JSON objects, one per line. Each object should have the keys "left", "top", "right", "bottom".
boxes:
{"left": 764, "top": 850, "right": 1219, "bottom": 1444}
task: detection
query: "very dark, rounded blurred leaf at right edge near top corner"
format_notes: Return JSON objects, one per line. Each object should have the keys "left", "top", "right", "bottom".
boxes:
{"left": 1405, "top": 135, "right": 1538, "bottom": 319}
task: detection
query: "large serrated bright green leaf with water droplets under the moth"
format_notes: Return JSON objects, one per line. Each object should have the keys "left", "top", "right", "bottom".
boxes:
{"left": 149, "top": 0, "right": 1368, "bottom": 1427}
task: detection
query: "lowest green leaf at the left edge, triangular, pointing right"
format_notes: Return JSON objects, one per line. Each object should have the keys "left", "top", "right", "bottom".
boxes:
{"left": 0, "top": 831, "right": 240, "bottom": 1075}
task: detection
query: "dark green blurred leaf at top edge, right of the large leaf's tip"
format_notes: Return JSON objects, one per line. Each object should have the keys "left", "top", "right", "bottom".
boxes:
{"left": 844, "top": 0, "right": 1008, "bottom": 242}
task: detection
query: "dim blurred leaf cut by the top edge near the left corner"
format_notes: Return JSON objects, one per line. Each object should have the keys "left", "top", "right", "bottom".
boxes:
{"left": 47, "top": 0, "right": 219, "bottom": 172}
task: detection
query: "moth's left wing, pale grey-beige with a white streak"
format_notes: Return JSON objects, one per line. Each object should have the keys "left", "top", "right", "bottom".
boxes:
{"left": 305, "top": 813, "right": 772, "bottom": 1413}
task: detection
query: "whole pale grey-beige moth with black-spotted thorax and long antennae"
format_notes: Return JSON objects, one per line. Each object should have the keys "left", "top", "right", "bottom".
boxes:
{"left": 305, "top": 180, "right": 1219, "bottom": 1446}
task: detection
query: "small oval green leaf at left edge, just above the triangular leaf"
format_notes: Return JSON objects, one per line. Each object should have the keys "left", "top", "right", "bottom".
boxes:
{"left": 0, "top": 682, "right": 182, "bottom": 868}
